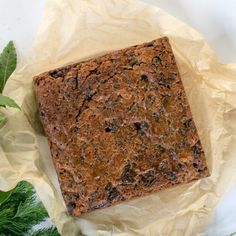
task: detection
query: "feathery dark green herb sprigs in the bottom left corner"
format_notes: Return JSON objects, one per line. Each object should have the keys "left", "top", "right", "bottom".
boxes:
{"left": 0, "top": 181, "right": 59, "bottom": 236}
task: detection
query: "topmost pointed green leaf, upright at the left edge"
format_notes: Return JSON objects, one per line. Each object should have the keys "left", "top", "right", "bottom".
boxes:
{"left": 0, "top": 41, "right": 17, "bottom": 93}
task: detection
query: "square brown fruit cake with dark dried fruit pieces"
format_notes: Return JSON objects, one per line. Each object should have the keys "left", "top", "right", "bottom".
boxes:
{"left": 34, "top": 37, "right": 209, "bottom": 216}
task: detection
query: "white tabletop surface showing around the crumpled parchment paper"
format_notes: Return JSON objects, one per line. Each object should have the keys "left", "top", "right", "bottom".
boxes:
{"left": 0, "top": 0, "right": 236, "bottom": 236}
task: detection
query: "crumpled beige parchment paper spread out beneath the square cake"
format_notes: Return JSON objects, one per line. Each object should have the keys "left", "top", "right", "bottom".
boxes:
{"left": 0, "top": 0, "right": 236, "bottom": 236}
